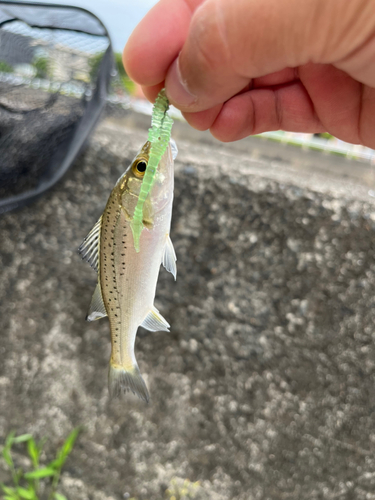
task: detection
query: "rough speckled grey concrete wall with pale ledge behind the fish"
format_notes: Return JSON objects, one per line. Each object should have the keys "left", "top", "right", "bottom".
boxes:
{"left": 0, "top": 115, "right": 375, "bottom": 500}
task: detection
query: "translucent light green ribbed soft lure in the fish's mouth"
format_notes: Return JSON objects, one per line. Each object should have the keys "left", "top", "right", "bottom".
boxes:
{"left": 130, "top": 89, "right": 173, "bottom": 252}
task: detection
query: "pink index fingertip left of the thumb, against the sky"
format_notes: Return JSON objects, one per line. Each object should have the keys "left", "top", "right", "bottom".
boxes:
{"left": 123, "top": 0, "right": 204, "bottom": 86}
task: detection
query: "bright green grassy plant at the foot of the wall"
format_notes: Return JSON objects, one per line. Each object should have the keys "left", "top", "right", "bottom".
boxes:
{"left": 0, "top": 428, "right": 80, "bottom": 500}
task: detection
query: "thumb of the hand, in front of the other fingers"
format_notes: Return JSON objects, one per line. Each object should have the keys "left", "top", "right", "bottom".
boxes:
{"left": 165, "top": 0, "right": 375, "bottom": 112}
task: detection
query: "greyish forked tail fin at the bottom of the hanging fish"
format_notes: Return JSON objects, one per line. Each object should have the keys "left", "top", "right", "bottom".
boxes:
{"left": 108, "top": 363, "right": 150, "bottom": 403}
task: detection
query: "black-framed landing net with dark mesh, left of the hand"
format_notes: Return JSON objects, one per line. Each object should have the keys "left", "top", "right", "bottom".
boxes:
{"left": 0, "top": 2, "right": 113, "bottom": 212}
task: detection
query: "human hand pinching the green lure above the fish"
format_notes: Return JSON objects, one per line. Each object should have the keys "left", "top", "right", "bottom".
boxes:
{"left": 123, "top": 0, "right": 375, "bottom": 148}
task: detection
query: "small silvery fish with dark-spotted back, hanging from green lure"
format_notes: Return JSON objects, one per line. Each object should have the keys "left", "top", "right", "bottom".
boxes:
{"left": 78, "top": 139, "right": 177, "bottom": 403}
